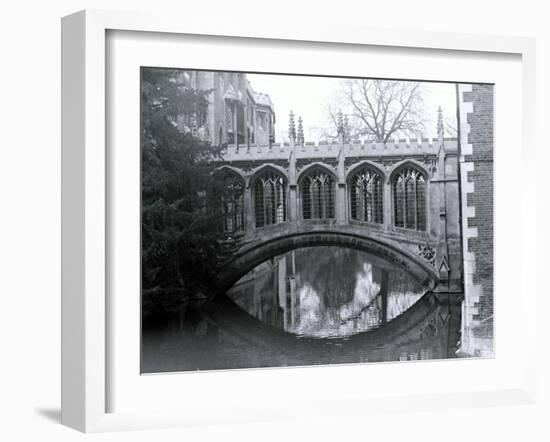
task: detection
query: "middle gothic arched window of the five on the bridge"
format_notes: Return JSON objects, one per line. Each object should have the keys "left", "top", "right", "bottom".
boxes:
{"left": 300, "top": 168, "right": 334, "bottom": 219}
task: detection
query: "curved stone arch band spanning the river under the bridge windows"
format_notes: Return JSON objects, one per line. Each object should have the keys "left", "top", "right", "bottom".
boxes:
{"left": 218, "top": 229, "right": 439, "bottom": 293}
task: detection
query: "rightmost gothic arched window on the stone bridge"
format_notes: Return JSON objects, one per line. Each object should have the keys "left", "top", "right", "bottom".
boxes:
{"left": 392, "top": 166, "right": 426, "bottom": 230}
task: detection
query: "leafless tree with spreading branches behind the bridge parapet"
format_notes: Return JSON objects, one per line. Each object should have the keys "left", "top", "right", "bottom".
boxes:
{"left": 327, "top": 79, "right": 425, "bottom": 143}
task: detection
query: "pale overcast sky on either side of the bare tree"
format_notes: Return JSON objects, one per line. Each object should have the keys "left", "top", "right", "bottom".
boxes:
{"left": 248, "top": 74, "right": 456, "bottom": 141}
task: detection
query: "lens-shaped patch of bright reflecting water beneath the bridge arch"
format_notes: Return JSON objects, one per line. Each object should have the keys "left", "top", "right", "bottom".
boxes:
{"left": 228, "top": 247, "right": 425, "bottom": 338}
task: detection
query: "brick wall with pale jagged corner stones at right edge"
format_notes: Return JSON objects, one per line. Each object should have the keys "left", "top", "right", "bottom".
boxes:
{"left": 458, "top": 84, "right": 494, "bottom": 356}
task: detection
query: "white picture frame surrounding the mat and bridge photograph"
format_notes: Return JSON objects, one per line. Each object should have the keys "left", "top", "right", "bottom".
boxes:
{"left": 62, "top": 10, "right": 536, "bottom": 432}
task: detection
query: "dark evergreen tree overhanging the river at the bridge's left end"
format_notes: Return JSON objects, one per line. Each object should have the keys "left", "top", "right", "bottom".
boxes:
{"left": 141, "top": 68, "right": 231, "bottom": 313}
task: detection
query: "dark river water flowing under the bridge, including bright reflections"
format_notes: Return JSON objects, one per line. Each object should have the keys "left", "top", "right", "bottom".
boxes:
{"left": 141, "top": 247, "right": 460, "bottom": 373}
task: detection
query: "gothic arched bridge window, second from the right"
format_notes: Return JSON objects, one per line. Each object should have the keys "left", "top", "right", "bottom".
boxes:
{"left": 350, "top": 166, "right": 384, "bottom": 224}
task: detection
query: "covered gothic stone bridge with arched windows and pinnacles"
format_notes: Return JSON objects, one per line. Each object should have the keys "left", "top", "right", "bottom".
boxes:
{"left": 215, "top": 110, "right": 463, "bottom": 293}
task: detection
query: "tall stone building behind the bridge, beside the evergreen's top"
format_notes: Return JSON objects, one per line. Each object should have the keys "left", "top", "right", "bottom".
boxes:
{"left": 178, "top": 71, "right": 275, "bottom": 146}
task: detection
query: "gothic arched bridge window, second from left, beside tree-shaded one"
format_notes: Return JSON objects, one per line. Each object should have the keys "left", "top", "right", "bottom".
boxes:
{"left": 253, "top": 170, "right": 286, "bottom": 227}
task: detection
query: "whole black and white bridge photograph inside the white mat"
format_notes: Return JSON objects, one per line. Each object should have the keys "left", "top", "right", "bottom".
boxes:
{"left": 140, "top": 66, "right": 495, "bottom": 374}
